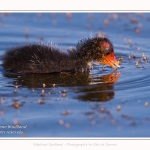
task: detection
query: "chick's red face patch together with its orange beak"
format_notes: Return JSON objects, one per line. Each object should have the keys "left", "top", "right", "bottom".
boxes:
{"left": 100, "top": 41, "right": 120, "bottom": 68}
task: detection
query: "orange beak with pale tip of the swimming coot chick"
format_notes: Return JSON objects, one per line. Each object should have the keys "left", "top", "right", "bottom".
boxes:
{"left": 101, "top": 52, "right": 120, "bottom": 68}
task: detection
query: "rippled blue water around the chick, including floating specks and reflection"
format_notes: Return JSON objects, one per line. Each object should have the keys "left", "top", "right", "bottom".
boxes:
{"left": 0, "top": 13, "right": 150, "bottom": 137}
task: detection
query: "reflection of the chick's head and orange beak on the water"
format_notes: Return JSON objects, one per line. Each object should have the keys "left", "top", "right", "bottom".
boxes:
{"left": 78, "top": 70, "right": 120, "bottom": 102}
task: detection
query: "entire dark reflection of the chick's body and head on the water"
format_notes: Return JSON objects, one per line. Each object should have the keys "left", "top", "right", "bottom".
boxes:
{"left": 4, "top": 70, "right": 119, "bottom": 101}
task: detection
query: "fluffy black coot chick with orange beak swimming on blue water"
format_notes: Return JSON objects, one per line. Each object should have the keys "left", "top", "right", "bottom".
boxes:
{"left": 2, "top": 37, "right": 119, "bottom": 73}
